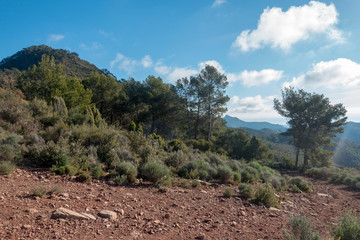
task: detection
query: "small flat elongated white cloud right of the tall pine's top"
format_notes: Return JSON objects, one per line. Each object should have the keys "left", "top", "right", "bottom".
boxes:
{"left": 227, "top": 69, "right": 283, "bottom": 87}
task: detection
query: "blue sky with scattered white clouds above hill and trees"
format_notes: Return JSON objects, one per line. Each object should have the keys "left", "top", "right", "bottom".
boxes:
{"left": 0, "top": 0, "right": 360, "bottom": 124}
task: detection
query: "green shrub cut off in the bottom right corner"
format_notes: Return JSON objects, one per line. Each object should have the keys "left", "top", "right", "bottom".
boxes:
{"left": 332, "top": 212, "right": 360, "bottom": 240}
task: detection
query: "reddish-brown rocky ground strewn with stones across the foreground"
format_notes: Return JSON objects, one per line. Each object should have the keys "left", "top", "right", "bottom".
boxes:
{"left": 0, "top": 169, "right": 360, "bottom": 240}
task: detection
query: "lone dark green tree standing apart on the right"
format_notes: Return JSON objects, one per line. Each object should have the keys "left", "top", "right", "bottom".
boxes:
{"left": 274, "top": 88, "right": 347, "bottom": 167}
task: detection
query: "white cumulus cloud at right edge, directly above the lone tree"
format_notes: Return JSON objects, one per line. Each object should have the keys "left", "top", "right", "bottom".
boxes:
{"left": 284, "top": 58, "right": 360, "bottom": 89}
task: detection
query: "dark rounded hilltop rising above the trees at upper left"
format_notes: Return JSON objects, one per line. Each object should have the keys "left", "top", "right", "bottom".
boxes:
{"left": 0, "top": 45, "right": 109, "bottom": 78}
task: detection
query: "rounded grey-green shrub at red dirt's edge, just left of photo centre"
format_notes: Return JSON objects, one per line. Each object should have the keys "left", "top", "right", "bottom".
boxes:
{"left": 141, "top": 162, "right": 170, "bottom": 183}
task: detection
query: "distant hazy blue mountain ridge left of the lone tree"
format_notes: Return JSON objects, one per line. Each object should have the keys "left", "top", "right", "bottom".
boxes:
{"left": 224, "top": 115, "right": 286, "bottom": 132}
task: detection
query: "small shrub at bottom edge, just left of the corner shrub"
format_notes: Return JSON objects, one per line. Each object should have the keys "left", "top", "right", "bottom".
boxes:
{"left": 283, "top": 217, "right": 320, "bottom": 240}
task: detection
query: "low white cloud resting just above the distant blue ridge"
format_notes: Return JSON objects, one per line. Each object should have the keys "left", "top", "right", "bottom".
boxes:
{"left": 227, "top": 95, "right": 279, "bottom": 122}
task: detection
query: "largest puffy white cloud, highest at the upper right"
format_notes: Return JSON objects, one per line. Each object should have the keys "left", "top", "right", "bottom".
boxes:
{"left": 233, "top": 1, "right": 343, "bottom": 51}
